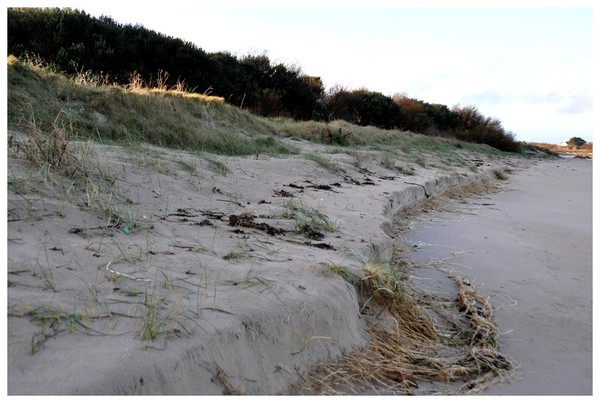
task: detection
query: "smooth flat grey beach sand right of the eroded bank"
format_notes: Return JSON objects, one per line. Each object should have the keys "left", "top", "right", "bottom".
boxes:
{"left": 402, "top": 158, "right": 593, "bottom": 395}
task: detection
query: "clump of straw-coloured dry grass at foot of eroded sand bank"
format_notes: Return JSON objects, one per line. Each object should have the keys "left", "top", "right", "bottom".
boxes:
{"left": 300, "top": 266, "right": 513, "bottom": 394}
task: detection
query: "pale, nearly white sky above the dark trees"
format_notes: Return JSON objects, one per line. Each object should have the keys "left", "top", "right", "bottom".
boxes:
{"left": 4, "top": 0, "right": 594, "bottom": 143}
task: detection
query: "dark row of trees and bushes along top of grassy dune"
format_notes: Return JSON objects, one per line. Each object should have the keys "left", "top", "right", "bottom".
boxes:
{"left": 7, "top": 8, "right": 518, "bottom": 151}
